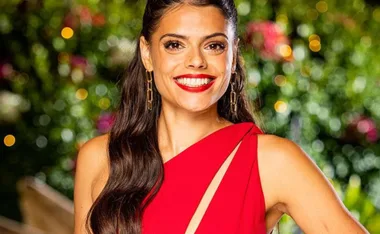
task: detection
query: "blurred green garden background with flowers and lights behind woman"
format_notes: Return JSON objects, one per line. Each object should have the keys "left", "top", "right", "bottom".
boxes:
{"left": 0, "top": 0, "right": 380, "bottom": 234}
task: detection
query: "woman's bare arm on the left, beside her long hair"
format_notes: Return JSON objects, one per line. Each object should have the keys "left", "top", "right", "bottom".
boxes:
{"left": 74, "top": 135, "right": 108, "bottom": 234}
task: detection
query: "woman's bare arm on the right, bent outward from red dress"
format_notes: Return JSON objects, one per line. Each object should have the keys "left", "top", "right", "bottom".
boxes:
{"left": 259, "top": 135, "right": 368, "bottom": 234}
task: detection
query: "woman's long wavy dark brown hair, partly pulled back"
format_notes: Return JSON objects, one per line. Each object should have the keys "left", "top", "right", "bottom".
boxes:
{"left": 86, "top": 0, "right": 264, "bottom": 234}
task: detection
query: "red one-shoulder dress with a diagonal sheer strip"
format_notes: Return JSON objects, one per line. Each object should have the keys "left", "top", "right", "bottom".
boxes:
{"left": 142, "top": 122, "right": 266, "bottom": 234}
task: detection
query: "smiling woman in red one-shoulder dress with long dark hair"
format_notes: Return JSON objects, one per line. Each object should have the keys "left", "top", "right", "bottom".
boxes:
{"left": 74, "top": 0, "right": 367, "bottom": 234}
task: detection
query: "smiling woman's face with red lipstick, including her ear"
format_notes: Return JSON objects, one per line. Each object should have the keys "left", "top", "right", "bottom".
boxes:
{"left": 140, "top": 4, "right": 237, "bottom": 112}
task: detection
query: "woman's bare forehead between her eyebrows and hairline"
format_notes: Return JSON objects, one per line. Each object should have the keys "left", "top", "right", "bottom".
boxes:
{"left": 153, "top": 4, "right": 234, "bottom": 39}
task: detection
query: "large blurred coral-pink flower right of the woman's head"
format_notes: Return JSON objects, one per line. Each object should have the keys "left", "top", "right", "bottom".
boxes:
{"left": 246, "top": 21, "right": 289, "bottom": 61}
